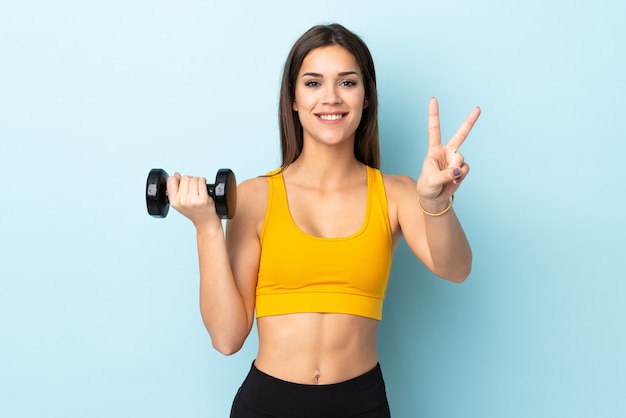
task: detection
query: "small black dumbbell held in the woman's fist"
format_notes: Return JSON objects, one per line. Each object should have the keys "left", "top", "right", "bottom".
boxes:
{"left": 146, "top": 168, "right": 237, "bottom": 219}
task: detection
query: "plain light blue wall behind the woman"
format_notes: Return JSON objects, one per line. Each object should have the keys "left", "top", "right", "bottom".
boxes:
{"left": 0, "top": 0, "right": 626, "bottom": 418}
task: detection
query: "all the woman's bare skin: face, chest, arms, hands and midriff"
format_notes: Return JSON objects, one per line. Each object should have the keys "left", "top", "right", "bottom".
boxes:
{"left": 168, "top": 46, "right": 480, "bottom": 384}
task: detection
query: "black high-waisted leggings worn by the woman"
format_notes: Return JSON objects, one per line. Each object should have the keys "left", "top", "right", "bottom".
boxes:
{"left": 230, "top": 364, "right": 390, "bottom": 418}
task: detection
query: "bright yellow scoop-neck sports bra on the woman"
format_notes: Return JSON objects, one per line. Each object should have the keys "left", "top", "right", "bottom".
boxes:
{"left": 256, "top": 167, "right": 392, "bottom": 320}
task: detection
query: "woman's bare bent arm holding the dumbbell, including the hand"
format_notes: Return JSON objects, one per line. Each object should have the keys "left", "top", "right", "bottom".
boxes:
{"left": 168, "top": 174, "right": 267, "bottom": 355}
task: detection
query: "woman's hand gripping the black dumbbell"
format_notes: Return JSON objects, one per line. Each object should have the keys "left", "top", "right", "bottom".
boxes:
{"left": 167, "top": 173, "right": 222, "bottom": 229}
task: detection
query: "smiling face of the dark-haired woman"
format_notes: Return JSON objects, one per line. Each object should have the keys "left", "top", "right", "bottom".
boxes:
{"left": 293, "top": 45, "right": 367, "bottom": 151}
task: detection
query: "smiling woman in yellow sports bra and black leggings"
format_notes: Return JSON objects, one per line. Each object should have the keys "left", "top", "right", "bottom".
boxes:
{"left": 168, "top": 24, "right": 480, "bottom": 418}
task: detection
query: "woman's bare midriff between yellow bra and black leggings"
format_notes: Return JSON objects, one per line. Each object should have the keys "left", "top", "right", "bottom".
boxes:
{"left": 255, "top": 313, "right": 378, "bottom": 385}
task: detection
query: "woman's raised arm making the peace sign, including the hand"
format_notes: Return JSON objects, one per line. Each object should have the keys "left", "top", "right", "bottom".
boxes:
{"left": 392, "top": 98, "right": 480, "bottom": 282}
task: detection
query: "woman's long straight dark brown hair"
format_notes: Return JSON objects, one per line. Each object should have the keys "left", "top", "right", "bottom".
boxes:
{"left": 278, "top": 23, "right": 380, "bottom": 169}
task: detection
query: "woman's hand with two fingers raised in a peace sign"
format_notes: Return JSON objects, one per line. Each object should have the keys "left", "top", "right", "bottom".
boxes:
{"left": 417, "top": 97, "right": 480, "bottom": 207}
